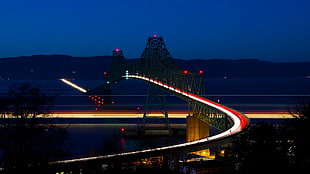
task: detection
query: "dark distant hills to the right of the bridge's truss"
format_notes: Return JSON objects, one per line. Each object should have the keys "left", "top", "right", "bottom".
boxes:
{"left": 176, "top": 59, "right": 310, "bottom": 78}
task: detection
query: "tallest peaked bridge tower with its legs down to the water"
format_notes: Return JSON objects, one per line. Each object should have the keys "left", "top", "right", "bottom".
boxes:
{"left": 140, "top": 35, "right": 172, "bottom": 134}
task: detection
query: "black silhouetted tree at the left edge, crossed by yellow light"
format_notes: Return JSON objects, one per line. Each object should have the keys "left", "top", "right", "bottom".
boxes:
{"left": 0, "top": 83, "right": 67, "bottom": 173}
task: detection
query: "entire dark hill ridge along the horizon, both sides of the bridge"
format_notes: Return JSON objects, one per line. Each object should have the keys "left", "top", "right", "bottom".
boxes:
{"left": 0, "top": 55, "right": 310, "bottom": 80}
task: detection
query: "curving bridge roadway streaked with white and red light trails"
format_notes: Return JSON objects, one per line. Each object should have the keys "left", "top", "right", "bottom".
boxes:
{"left": 50, "top": 74, "right": 249, "bottom": 165}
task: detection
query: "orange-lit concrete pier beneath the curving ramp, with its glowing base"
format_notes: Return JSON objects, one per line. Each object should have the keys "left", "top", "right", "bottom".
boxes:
{"left": 186, "top": 116, "right": 210, "bottom": 158}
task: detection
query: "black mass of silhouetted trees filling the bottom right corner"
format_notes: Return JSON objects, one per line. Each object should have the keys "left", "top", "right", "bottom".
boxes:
{"left": 224, "top": 102, "right": 310, "bottom": 173}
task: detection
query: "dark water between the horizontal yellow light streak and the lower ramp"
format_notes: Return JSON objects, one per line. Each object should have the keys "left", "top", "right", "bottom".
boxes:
{"left": 58, "top": 123, "right": 186, "bottom": 157}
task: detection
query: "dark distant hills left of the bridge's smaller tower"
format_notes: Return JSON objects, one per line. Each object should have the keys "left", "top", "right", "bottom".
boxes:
{"left": 0, "top": 55, "right": 112, "bottom": 80}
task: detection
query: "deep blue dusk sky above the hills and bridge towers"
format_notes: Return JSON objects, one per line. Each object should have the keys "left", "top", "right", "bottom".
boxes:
{"left": 0, "top": 0, "right": 310, "bottom": 62}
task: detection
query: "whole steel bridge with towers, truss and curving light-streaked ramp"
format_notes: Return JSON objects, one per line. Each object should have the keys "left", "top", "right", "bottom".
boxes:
{"left": 49, "top": 35, "right": 249, "bottom": 173}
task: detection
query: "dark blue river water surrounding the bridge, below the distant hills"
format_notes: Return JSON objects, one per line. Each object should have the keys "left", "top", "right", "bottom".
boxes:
{"left": 0, "top": 77, "right": 310, "bottom": 157}
